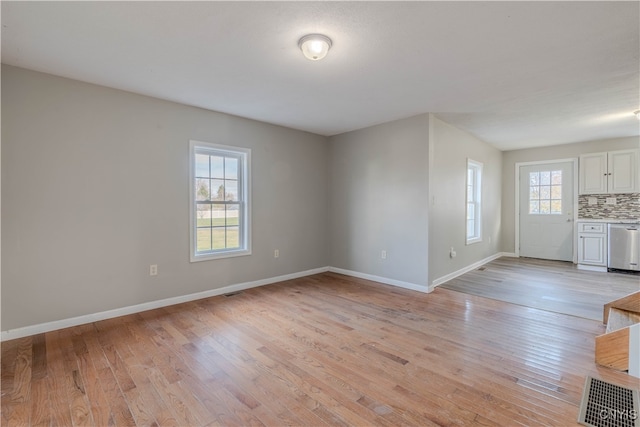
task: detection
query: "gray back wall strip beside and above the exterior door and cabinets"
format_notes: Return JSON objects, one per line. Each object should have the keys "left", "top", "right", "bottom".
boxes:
{"left": 502, "top": 137, "right": 640, "bottom": 252}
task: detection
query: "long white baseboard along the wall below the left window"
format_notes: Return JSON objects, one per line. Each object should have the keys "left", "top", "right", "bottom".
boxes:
{"left": 0, "top": 267, "right": 329, "bottom": 341}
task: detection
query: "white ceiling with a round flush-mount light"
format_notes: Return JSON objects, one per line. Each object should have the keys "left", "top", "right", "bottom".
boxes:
{"left": 1, "top": 1, "right": 640, "bottom": 150}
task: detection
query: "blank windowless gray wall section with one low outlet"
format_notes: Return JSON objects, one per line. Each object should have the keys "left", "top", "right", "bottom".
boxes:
{"left": 328, "top": 114, "right": 429, "bottom": 289}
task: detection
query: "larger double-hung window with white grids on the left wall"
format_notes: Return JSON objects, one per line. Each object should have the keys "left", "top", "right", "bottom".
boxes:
{"left": 189, "top": 141, "right": 251, "bottom": 262}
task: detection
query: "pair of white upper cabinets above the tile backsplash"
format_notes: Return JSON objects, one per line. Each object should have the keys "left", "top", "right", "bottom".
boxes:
{"left": 579, "top": 150, "right": 640, "bottom": 194}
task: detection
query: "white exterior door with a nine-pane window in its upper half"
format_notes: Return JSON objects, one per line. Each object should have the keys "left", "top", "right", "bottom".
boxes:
{"left": 519, "top": 161, "right": 574, "bottom": 261}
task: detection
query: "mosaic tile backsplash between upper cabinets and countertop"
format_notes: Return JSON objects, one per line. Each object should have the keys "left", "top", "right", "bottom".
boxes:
{"left": 578, "top": 193, "right": 640, "bottom": 219}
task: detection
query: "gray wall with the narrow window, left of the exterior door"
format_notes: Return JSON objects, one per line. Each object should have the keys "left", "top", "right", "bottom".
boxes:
{"left": 429, "top": 116, "right": 502, "bottom": 284}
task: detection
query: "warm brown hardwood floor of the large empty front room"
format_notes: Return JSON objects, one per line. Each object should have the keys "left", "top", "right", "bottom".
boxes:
{"left": 1, "top": 273, "right": 637, "bottom": 426}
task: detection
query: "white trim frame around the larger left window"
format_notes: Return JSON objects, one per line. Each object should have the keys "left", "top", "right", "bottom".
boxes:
{"left": 189, "top": 140, "right": 251, "bottom": 262}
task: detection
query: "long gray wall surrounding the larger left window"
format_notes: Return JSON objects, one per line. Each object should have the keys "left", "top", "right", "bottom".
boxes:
{"left": 1, "top": 65, "right": 328, "bottom": 330}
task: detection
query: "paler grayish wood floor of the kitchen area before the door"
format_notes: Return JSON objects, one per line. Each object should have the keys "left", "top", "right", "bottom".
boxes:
{"left": 441, "top": 257, "right": 640, "bottom": 320}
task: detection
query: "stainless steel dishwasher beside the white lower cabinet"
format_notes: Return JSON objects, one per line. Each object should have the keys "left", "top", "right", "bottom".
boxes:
{"left": 607, "top": 224, "right": 640, "bottom": 271}
